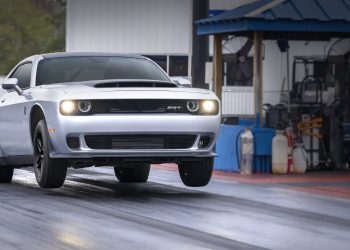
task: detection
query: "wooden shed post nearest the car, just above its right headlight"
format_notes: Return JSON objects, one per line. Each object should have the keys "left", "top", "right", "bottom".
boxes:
{"left": 213, "top": 35, "right": 222, "bottom": 101}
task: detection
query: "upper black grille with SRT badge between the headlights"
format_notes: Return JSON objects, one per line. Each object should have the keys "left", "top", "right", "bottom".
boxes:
{"left": 89, "top": 99, "right": 189, "bottom": 114}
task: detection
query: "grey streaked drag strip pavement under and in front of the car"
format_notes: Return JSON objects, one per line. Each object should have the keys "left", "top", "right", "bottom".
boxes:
{"left": 0, "top": 165, "right": 350, "bottom": 249}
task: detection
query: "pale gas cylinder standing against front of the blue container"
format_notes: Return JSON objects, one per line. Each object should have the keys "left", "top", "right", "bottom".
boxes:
{"left": 239, "top": 128, "right": 254, "bottom": 174}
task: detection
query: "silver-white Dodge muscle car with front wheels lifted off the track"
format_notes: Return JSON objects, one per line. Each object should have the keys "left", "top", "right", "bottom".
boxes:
{"left": 0, "top": 53, "right": 220, "bottom": 188}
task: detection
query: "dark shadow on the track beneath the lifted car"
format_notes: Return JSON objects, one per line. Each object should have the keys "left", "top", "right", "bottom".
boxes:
{"left": 9, "top": 169, "right": 213, "bottom": 201}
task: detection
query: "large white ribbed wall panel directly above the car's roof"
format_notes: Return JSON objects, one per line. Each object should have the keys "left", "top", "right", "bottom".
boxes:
{"left": 66, "top": 0, "right": 192, "bottom": 54}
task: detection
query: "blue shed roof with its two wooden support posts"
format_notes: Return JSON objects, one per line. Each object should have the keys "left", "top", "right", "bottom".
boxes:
{"left": 197, "top": 0, "right": 350, "bottom": 122}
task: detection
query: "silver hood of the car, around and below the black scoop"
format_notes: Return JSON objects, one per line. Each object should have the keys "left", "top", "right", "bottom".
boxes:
{"left": 40, "top": 81, "right": 216, "bottom": 99}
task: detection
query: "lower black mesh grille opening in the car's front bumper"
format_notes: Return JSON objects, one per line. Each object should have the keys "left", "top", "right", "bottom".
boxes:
{"left": 85, "top": 135, "right": 196, "bottom": 149}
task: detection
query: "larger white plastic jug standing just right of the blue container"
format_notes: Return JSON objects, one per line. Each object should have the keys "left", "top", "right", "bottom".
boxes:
{"left": 272, "top": 130, "right": 288, "bottom": 174}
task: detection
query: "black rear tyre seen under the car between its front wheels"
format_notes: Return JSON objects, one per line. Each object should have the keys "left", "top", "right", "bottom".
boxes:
{"left": 114, "top": 164, "right": 150, "bottom": 182}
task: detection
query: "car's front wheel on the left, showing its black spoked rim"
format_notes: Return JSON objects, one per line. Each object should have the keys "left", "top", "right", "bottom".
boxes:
{"left": 33, "top": 120, "right": 67, "bottom": 188}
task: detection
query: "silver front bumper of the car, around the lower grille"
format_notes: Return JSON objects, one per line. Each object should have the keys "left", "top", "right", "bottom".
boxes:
{"left": 47, "top": 114, "right": 220, "bottom": 159}
